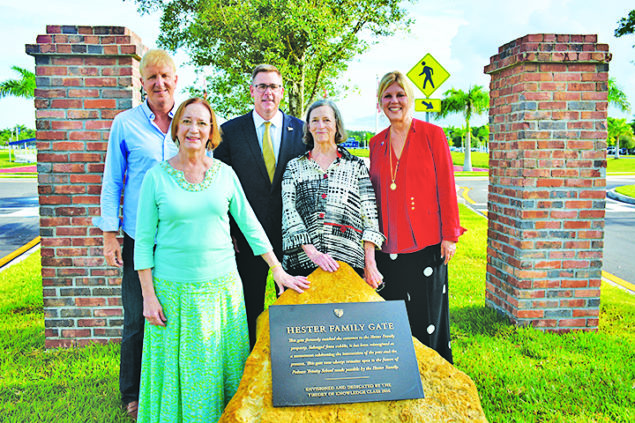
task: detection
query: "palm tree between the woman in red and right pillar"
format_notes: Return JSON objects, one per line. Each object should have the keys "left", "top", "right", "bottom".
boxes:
{"left": 435, "top": 85, "right": 489, "bottom": 171}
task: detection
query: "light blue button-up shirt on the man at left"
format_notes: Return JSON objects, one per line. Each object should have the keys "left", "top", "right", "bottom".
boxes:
{"left": 93, "top": 101, "right": 178, "bottom": 239}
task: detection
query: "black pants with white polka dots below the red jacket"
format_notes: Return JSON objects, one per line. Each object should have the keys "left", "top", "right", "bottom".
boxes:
{"left": 376, "top": 244, "right": 453, "bottom": 363}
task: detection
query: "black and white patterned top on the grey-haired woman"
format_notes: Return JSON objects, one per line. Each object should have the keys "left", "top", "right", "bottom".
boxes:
{"left": 282, "top": 146, "right": 385, "bottom": 269}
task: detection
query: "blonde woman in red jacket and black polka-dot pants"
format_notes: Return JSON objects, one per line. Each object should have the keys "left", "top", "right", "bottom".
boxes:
{"left": 370, "top": 71, "right": 465, "bottom": 363}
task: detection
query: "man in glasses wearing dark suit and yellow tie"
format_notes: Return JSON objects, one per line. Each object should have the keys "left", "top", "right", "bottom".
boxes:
{"left": 214, "top": 65, "right": 306, "bottom": 348}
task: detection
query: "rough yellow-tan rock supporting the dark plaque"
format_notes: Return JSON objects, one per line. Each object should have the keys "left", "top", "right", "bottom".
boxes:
{"left": 220, "top": 263, "right": 487, "bottom": 423}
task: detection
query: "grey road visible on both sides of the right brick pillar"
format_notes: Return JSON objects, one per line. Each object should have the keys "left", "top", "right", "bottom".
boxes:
{"left": 456, "top": 176, "right": 635, "bottom": 283}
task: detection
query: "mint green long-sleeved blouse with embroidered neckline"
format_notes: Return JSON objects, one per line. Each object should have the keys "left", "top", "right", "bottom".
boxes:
{"left": 134, "top": 160, "right": 272, "bottom": 281}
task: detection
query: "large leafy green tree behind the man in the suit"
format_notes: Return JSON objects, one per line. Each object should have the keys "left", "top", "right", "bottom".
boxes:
{"left": 135, "top": 0, "right": 414, "bottom": 116}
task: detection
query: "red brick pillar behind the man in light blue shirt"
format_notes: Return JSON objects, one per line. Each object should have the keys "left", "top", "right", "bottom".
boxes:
{"left": 26, "top": 25, "right": 146, "bottom": 348}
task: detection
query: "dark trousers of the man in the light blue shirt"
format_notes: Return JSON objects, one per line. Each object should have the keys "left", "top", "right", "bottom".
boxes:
{"left": 119, "top": 232, "right": 145, "bottom": 404}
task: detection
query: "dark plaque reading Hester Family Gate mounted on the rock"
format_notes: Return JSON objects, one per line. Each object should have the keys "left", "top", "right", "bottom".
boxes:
{"left": 269, "top": 301, "right": 423, "bottom": 407}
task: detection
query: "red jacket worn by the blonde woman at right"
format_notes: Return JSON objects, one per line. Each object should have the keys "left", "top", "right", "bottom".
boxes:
{"left": 370, "top": 119, "right": 465, "bottom": 253}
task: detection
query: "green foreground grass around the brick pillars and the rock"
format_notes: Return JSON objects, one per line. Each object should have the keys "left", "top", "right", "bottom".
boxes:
{"left": 0, "top": 205, "right": 635, "bottom": 422}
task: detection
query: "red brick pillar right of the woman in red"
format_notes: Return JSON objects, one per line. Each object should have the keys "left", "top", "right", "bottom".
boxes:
{"left": 485, "top": 34, "right": 611, "bottom": 332}
